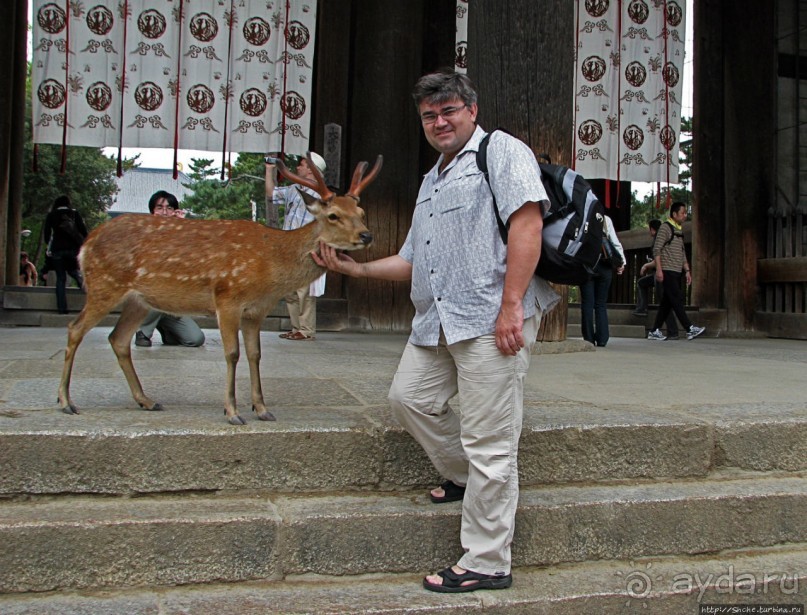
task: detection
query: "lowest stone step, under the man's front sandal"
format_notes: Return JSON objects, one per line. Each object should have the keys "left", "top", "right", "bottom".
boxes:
{"left": 6, "top": 544, "right": 807, "bottom": 615}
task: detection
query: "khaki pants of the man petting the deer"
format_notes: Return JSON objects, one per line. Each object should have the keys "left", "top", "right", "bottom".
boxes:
{"left": 389, "top": 312, "right": 541, "bottom": 574}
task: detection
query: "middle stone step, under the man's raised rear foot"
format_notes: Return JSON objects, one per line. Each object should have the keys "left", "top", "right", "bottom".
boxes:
{"left": 0, "top": 475, "right": 807, "bottom": 596}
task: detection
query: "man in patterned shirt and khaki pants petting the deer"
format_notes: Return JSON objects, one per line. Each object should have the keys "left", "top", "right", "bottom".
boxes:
{"left": 314, "top": 72, "right": 558, "bottom": 593}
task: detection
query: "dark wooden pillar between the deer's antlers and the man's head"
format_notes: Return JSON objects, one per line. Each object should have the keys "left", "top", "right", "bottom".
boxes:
{"left": 315, "top": 0, "right": 456, "bottom": 331}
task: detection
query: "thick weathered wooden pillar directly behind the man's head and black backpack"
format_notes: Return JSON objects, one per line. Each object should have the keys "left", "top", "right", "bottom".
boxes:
{"left": 468, "top": 0, "right": 574, "bottom": 341}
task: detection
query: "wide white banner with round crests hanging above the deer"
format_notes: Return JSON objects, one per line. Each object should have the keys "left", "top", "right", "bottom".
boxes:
{"left": 33, "top": 0, "right": 317, "bottom": 161}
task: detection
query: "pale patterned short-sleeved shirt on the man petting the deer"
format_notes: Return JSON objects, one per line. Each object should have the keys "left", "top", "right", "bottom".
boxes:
{"left": 398, "top": 126, "right": 559, "bottom": 346}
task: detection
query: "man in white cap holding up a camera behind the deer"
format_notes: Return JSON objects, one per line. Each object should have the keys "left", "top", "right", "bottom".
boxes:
{"left": 267, "top": 152, "right": 326, "bottom": 341}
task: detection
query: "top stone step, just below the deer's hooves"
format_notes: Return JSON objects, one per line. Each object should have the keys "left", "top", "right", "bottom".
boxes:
{"left": 0, "top": 400, "right": 807, "bottom": 495}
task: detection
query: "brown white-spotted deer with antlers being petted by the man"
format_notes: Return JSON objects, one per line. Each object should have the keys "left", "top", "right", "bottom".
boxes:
{"left": 58, "top": 153, "right": 383, "bottom": 425}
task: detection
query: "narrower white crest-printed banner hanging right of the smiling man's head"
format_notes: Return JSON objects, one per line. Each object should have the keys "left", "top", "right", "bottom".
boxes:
{"left": 573, "top": 0, "right": 686, "bottom": 183}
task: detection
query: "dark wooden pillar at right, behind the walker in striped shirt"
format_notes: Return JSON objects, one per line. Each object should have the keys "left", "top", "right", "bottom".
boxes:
{"left": 693, "top": 0, "right": 776, "bottom": 331}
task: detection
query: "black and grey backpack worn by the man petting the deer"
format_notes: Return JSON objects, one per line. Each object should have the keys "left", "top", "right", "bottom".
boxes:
{"left": 476, "top": 131, "right": 605, "bottom": 285}
